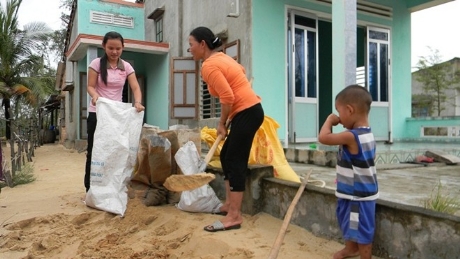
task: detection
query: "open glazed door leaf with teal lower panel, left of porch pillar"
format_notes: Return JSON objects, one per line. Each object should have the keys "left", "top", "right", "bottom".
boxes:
{"left": 287, "top": 11, "right": 318, "bottom": 143}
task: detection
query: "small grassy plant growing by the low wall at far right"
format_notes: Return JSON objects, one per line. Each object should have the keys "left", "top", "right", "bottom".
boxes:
{"left": 423, "top": 181, "right": 460, "bottom": 214}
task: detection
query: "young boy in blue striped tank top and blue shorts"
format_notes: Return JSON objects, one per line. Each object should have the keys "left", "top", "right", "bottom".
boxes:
{"left": 318, "top": 85, "right": 378, "bottom": 259}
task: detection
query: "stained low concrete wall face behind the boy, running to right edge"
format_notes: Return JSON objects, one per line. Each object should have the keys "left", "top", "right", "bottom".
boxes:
{"left": 262, "top": 178, "right": 460, "bottom": 259}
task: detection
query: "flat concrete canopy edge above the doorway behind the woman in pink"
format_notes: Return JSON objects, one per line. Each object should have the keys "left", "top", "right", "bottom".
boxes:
{"left": 65, "top": 34, "right": 169, "bottom": 61}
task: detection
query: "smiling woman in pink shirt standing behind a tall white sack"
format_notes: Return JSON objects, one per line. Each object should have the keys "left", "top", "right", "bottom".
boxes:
{"left": 84, "top": 31, "right": 145, "bottom": 192}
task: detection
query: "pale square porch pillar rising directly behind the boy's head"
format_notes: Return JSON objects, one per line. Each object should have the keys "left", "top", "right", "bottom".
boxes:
{"left": 332, "top": 0, "right": 357, "bottom": 101}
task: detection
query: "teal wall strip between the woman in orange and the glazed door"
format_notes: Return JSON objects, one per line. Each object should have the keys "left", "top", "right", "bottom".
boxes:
{"left": 252, "top": 0, "right": 287, "bottom": 140}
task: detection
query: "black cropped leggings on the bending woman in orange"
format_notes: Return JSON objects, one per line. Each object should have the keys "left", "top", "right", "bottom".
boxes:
{"left": 220, "top": 103, "right": 264, "bottom": 192}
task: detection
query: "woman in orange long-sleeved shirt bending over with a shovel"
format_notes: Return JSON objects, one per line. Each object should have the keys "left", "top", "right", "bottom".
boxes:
{"left": 189, "top": 27, "right": 264, "bottom": 232}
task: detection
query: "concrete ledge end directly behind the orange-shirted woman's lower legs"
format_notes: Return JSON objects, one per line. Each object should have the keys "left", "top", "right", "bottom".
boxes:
{"left": 206, "top": 165, "right": 273, "bottom": 215}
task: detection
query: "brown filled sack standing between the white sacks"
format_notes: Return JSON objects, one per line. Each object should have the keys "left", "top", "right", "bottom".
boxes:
{"left": 130, "top": 124, "right": 201, "bottom": 206}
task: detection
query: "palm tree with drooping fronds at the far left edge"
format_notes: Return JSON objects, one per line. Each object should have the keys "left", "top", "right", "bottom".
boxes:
{"left": 0, "top": 0, "right": 54, "bottom": 139}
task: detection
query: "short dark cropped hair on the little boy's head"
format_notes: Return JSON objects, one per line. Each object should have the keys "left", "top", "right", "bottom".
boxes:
{"left": 335, "top": 85, "right": 372, "bottom": 114}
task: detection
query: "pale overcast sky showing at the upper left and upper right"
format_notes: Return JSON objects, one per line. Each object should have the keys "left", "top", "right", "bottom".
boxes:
{"left": 0, "top": 0, "right": 460, "bottom": 66}
